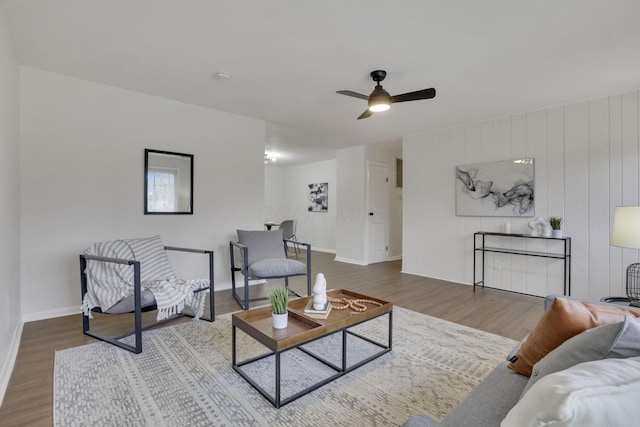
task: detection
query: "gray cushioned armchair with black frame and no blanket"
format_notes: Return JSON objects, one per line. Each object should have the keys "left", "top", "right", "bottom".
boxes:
{"left": 229, "top": 230, "right": 311, "bottom": 310}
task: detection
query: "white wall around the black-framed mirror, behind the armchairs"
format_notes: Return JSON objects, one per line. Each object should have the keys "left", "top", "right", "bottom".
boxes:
{"left": 20, "top": 67, "right": 265, "bottom": 320}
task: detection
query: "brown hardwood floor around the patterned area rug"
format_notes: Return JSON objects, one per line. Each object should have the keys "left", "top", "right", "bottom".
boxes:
{"left": 0, "top": 252, "right": 543, "bottom": 426}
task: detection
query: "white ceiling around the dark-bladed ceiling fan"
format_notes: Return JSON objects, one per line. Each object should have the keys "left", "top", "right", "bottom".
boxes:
{"left": 5, "top": 0, "right": 640, "bottom": 165}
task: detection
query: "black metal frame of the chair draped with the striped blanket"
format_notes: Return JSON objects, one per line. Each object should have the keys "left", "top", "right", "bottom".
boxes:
{"left": 80, "top": 246, "right": 215, "bottom": 354}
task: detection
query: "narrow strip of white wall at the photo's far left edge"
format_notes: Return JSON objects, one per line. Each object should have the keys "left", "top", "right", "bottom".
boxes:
{"left": 0, "top": 3, "right": 22, "bottom": 404}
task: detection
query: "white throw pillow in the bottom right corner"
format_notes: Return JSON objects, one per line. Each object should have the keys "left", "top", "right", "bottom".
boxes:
{"left": 501, "top": 357, "right": 640, "bottom": 427}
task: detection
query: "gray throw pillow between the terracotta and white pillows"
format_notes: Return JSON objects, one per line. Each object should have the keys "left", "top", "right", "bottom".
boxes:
{"left": 520, "top": 316, "right": 640, "bottom": 399}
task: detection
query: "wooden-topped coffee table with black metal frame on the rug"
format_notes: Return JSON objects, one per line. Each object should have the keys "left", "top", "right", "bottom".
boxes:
{"left": 231, "top": 289, "right": 393, "bottom": 408}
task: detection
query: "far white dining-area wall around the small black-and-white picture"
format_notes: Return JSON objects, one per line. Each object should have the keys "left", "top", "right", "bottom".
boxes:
{"left": 265, "top": 160, "right": 338, "bottom": 253}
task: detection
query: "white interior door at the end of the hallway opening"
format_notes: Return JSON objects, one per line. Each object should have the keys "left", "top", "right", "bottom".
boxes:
{"left": 367, "top": 162, "right": 389, "bottom": 264}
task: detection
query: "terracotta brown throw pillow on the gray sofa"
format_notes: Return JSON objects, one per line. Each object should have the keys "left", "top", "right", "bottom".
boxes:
{"left": 508, "top": 298, "right": 640, "bottom": 377}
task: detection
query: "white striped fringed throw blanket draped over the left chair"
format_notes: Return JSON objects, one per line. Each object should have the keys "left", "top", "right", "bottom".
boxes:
{"left": 82, "top": 236, "right": 209, "bottom": 320}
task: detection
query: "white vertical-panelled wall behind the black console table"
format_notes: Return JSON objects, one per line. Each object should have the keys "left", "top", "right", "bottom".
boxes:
{"left": 403, "top": 91, "right": 640, "bottom": 298}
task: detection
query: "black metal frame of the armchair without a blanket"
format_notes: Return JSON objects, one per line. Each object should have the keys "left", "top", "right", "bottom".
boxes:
{"left": 229, "top": 239, "right": 311, "bottom": 310}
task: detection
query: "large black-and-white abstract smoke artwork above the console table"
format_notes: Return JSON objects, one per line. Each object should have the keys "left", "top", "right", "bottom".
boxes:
{"left": 456, "top": 157, "right": 535, "bottom": 216}
